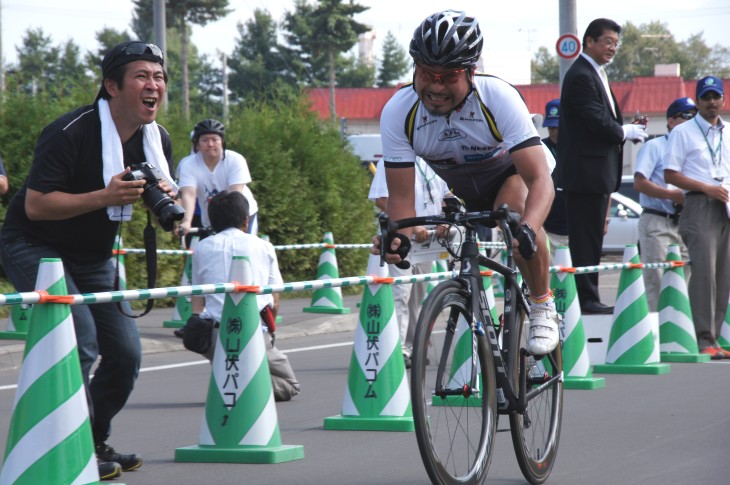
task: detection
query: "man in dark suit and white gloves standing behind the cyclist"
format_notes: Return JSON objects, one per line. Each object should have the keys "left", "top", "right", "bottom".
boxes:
{"left": 558, "top": 19, "right": 648, "bottom": 313}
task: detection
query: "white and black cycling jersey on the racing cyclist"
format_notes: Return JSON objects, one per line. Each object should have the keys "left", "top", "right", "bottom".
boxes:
{"left": 380, "top": 74, "right": 554, "bottom": 198}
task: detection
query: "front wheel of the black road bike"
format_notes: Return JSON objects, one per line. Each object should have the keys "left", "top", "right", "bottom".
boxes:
{"left": 411, "top": 281, "right": 497, "bottom": 484}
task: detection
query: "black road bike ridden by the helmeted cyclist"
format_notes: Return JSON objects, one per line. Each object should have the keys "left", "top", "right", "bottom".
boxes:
{"left": 380, "top": 200, "right": 563, "bottom": 484}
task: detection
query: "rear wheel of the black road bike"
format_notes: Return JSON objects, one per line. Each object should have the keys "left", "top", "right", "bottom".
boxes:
{"left": 508, "top": 300, "right": 563, "bottom": 484}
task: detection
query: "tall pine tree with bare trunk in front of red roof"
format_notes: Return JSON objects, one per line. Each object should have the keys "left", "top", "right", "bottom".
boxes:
{"left": 284, "top": 0, "right": 370, "bottom": 121}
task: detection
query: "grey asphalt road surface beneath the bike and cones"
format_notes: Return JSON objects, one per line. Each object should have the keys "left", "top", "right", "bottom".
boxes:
{"left": 0, "top": 266, "right": 730, "bottom": 485}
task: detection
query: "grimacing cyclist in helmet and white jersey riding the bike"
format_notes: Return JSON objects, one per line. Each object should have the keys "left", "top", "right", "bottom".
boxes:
{"left": 374, "top": 10, "right": 559, "bottom": 355}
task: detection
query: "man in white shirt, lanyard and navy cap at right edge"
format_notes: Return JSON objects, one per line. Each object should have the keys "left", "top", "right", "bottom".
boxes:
{"left": 664, "top": 76, "right": 730, "bottom": 359}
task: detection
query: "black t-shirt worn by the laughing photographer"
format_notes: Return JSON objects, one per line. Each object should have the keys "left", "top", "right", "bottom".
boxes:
{"left": 2, "top": 104, "right": 172, "bottom": 263}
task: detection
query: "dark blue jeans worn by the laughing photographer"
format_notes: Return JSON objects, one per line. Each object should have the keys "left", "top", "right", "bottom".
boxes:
{"left": 0, "top": 234, "right": 142, "bottom": 443}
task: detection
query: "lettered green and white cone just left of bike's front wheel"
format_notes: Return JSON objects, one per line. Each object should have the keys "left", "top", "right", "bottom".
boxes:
{"left": 324, "top": 255, "right": 414, "bottom": 431}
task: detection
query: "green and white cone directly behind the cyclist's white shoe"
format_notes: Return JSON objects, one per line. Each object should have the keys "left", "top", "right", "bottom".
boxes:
{"left": 550, "top": 246, "right": 606, "bottom": 390}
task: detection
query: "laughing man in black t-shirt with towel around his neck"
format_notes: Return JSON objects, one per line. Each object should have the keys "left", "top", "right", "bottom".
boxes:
{"left": 0, "top": 42, "right": 174, "bottom": 479}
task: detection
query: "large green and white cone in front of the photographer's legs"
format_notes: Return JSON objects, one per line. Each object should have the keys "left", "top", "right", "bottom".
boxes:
{"left": 0, "top": 258, "right": 99, "bottom": 485}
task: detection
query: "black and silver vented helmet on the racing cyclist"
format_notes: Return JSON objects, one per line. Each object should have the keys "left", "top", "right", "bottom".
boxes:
{"left": 409, "top": 10, "right": 484, "bottom": 68}
